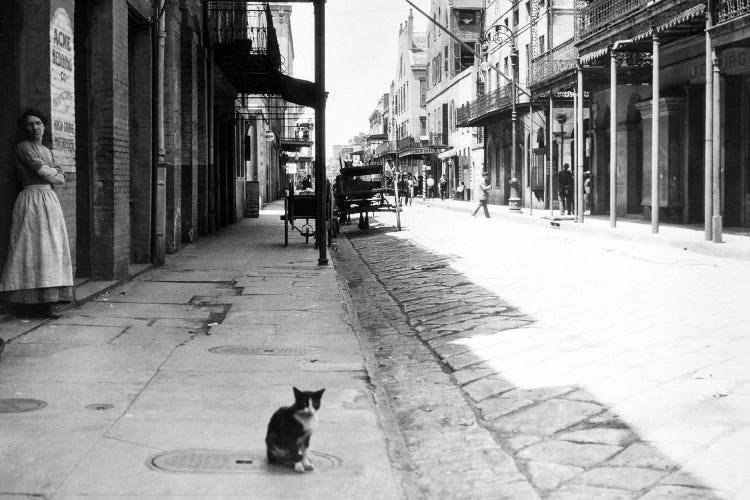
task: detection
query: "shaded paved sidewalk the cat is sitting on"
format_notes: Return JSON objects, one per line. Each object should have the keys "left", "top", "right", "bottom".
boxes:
{"left": 0, "top": 202, "right": 403, "bottom": 499}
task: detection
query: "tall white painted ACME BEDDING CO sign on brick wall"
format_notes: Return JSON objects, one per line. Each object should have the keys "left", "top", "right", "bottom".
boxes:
{"left": 50, "top": 8, "right": 76, "bottom": 172}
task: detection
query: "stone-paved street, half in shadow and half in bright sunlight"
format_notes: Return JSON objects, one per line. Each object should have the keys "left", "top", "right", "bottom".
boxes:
{"left": 333, "top": 204, "right": 750, "bottom": 499}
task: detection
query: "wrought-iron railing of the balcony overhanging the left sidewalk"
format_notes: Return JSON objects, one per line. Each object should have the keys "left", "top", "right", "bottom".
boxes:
{"left": 208, "top": 2, "right": 270, "bottom": 54}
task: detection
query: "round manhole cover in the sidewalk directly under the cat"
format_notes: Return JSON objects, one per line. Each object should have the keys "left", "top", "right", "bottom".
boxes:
{"left": 146, "top": 450, "right": 342, "bottom": 474}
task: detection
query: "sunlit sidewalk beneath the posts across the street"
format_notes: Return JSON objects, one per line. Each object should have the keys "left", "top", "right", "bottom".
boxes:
{"left": 418, "top": 197, "right": 750, "bottom": 260}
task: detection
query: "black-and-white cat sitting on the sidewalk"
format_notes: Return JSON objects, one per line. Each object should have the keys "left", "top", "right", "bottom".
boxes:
{"left": 266, "top": 387, "right": 325, "bottom": 472}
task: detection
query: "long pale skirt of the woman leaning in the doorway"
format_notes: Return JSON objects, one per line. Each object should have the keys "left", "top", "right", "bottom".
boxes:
{"left": 0, "top": 184, "right": 73, "bottom": 304}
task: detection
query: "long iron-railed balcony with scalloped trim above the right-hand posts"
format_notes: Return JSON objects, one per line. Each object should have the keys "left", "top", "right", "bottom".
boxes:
{"left": 575, "top": 0, "right": 708, "bottom": 62}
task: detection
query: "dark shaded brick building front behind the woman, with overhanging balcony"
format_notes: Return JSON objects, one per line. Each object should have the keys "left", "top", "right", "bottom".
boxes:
{"left": 0, "top": 0, "right": 314, "bottom": 288}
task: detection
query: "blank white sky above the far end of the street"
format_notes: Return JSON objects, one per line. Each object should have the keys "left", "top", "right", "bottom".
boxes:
{"left": 291, "top": 0, "right": 430, "bottom": 152}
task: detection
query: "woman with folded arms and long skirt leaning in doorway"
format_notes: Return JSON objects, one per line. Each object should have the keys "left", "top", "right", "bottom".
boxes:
{"left": 0, "top": 110, "right": 74, "bottom": 317}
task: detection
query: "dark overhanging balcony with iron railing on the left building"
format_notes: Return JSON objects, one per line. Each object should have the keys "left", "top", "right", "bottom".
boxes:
{"left": 208, "top": 0, "right": 316, "bottom": 107}
